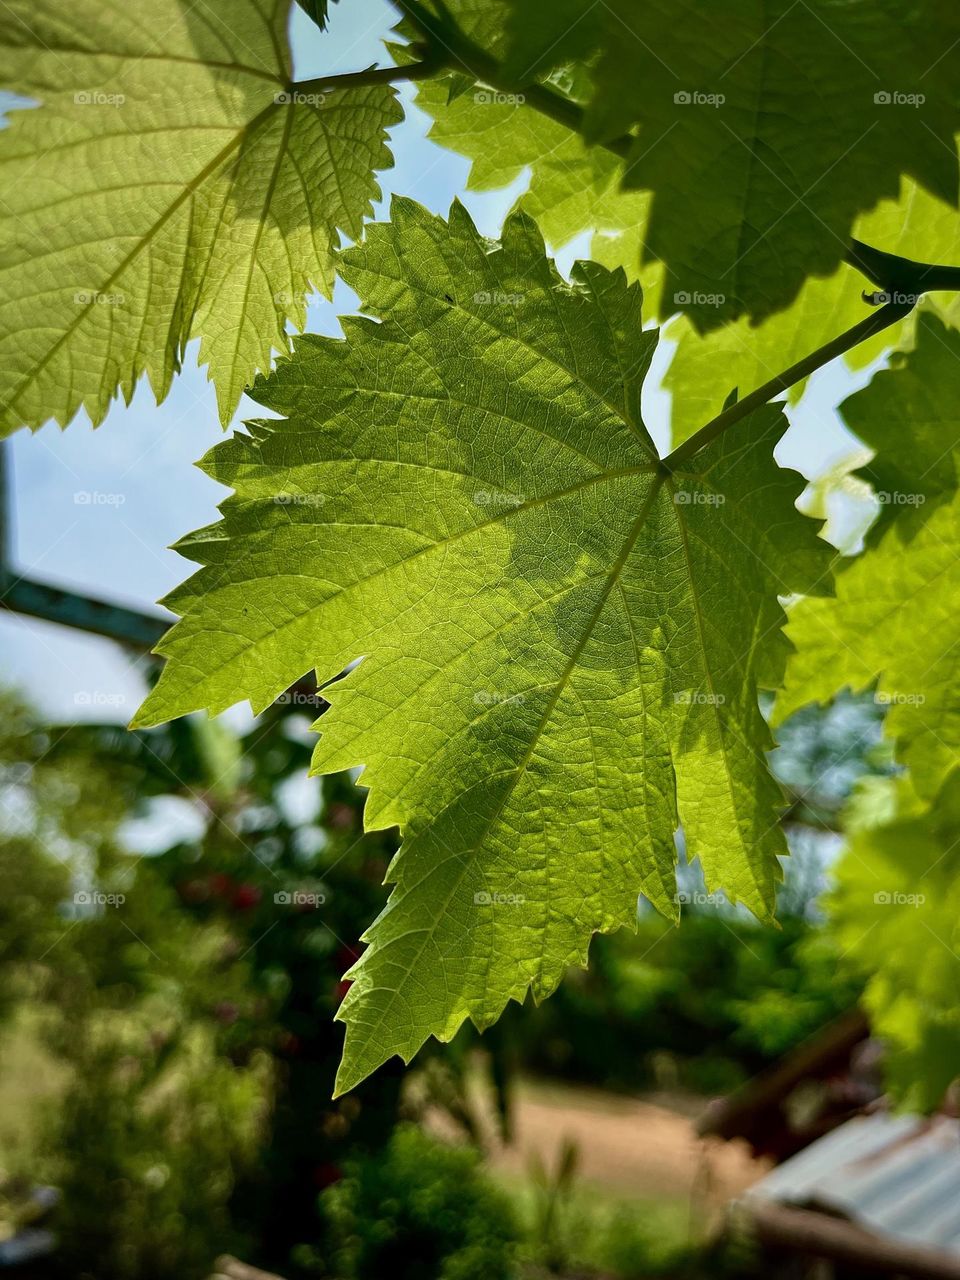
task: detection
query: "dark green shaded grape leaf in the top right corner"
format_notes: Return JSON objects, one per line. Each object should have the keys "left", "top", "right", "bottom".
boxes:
{"left": 508, "top": 0, "right": 960, "bottom": 332}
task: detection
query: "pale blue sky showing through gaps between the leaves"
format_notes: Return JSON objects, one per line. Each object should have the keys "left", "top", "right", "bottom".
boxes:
{"left": 0, "top": 0, "right": 869, "bottom": 722}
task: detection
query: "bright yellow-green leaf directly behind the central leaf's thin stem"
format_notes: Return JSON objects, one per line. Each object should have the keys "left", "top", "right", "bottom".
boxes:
{"left": 664, "top": 180, "right": 960, "bottom": 445}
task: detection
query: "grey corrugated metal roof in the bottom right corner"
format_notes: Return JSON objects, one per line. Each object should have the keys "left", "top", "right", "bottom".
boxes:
{"left": 748, "top": 1112, "right": 960, "bottom": 1257}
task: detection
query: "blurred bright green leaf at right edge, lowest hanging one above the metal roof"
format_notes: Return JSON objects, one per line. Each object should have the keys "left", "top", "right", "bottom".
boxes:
{"left": 827, "top": 773, "right": 960, "bottom": 1111}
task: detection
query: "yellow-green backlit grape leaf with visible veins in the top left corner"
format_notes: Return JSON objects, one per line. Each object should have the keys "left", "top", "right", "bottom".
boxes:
{"left": 0, "top": 0, "right": 401, "bottom": 431}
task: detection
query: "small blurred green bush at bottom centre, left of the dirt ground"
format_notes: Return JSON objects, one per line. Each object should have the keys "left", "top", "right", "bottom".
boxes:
{"left": 321, "top": 1128, "right": 517, "bottom": 1280}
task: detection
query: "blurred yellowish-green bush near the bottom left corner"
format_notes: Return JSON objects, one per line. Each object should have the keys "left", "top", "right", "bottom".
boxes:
{"left": 52, "top": 1019, "right": 269, "bottom": 1280}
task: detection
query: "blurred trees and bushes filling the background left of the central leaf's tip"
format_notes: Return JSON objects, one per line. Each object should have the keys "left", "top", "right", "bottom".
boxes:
{"left": 0, "top": 696, "right": 470, "bottom": 1280}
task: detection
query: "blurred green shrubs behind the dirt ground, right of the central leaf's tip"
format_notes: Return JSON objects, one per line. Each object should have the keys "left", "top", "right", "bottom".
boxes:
{"left": 511, "top": 910, "right": 860, "bottom": 1093}
